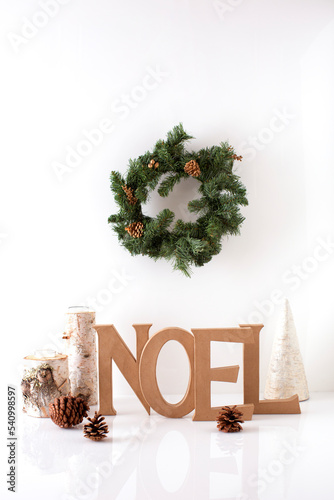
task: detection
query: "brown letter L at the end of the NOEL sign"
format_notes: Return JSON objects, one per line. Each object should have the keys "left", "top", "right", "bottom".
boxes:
{"left": 240, "top": 325, "right": 300, "bottom": 414}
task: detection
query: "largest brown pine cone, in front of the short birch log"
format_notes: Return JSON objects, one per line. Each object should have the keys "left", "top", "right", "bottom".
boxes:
{"left": 49, "top": 396, "right": 89, "bottom": 429}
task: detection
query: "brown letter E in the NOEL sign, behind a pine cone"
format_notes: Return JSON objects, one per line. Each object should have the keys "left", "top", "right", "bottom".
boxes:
{"left": 191, "top": 327, "right": 254, "bottom": 420}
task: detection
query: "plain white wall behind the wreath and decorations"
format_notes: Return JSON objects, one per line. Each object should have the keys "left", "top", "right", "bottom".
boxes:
{"left": 0, "top": 0, "right": 334, "bottom": 395}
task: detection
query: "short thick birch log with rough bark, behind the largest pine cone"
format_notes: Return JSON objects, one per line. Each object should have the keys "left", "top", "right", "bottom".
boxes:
{"left": 21, "top": 352, "right": 69, "bottom": 417}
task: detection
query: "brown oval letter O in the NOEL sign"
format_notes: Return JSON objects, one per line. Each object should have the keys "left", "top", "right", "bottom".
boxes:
{"left": 140, "top": 328, "right": 195, "bottom": 418}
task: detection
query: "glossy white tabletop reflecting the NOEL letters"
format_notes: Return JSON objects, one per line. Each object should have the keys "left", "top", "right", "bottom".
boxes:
{"left": 6, "top": 393, "right": 334, "bottom": 500}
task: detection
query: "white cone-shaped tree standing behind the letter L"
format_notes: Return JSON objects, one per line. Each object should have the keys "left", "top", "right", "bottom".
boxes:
{"left": 264, "top": 299, "right": 309, "bottom": 401}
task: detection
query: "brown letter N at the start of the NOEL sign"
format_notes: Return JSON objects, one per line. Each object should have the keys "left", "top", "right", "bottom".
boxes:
{"left": 94, "top": 325, "right": 152, "bottom": 415}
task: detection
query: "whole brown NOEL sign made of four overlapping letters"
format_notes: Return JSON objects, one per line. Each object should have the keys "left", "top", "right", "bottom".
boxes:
{"left": 94, "top": 324, "right": 300, "bottom": 421}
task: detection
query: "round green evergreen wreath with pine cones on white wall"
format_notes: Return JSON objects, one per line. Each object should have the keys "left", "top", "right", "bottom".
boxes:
{"left": 108, "top": 124, "right": 248, "bottom": 277}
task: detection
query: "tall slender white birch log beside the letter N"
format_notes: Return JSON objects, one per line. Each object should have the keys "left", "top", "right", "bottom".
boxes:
{"left": 63, "top": 308, "right": 97, "bottom": 405}
